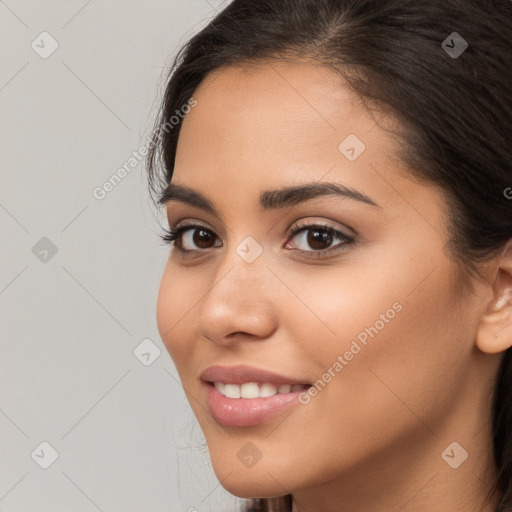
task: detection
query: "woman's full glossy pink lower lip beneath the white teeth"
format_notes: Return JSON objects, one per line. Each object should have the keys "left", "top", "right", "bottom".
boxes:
{"left": 206, "top": 383, "right": 304, "bottom": 427}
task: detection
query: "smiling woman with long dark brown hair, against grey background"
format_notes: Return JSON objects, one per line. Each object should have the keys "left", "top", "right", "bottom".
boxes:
{"left": 144, "top": 0, "right": 512, "bottom": 512}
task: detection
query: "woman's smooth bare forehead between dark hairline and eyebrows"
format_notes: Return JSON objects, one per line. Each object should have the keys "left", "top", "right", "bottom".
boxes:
{"left": 175, "top": 62, "right": 395, "bottom": 182}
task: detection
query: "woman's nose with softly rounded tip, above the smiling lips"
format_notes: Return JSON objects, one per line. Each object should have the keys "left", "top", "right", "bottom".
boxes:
{"left": 196, "top": 242, "right": 277, "bottom": 347}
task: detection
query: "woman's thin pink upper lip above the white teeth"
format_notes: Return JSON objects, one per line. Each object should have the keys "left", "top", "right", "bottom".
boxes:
{"left": 201, "top": 365, "right": 309, "bottom": 385}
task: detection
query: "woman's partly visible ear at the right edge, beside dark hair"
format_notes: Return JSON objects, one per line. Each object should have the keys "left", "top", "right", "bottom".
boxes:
{"left": 476, "top": 239, "right": 512, "bottom": 354}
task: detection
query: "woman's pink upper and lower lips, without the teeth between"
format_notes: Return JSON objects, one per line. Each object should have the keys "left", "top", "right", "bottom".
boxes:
{"left": 201, "top": 365, "right": 309, "bottom": 427}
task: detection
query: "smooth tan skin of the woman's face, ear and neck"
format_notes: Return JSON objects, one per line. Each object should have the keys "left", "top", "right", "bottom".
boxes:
{"left": 157, "top": 62, "right": 512, "bottom": 512}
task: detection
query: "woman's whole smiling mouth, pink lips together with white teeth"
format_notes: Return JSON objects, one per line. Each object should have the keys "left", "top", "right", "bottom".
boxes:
{"left": 201, "top": 365, "right": 311, "bottom": 427}
